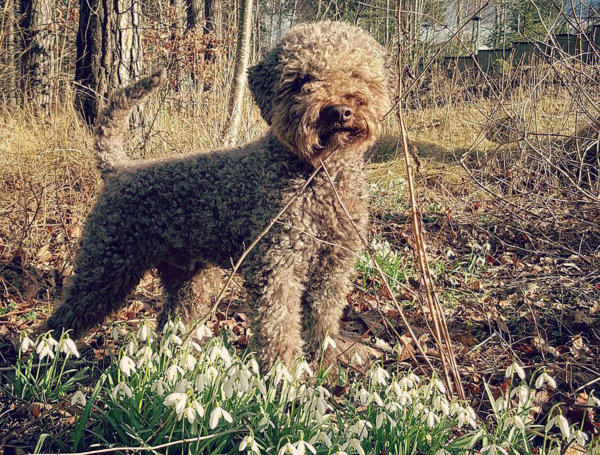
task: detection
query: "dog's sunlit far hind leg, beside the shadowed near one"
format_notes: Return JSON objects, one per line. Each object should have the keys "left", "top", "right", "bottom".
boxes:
{"left": 158, "top": 263, "right": 223, "bottom": 328}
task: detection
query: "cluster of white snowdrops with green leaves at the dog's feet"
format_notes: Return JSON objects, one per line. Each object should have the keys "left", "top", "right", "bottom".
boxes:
{"left": 19, "top": 321, "right": 600, "bottom": 455}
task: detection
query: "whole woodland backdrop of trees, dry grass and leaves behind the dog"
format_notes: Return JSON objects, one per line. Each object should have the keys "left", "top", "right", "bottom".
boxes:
{"left": 0, "top": 0, "right": 600, "bottom": 452}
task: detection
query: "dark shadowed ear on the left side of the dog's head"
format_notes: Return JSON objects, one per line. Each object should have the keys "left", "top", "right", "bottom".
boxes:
{"left": 248, "top": 46, "right": 281, "bottom": 125}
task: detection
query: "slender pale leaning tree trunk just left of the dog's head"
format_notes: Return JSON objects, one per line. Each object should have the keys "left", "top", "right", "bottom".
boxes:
{"left": 225, "top": 0, "right": 253, "bottom": 145}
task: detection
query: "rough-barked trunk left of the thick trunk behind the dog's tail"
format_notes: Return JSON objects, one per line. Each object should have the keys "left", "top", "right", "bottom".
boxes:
{"left": 21, "top": 0, "right": 55, "bottom": 110}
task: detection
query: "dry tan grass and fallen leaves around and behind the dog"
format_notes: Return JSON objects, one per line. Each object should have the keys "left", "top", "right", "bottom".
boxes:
{"left": 0, "top": 39, "right": 600, "bottom": 446}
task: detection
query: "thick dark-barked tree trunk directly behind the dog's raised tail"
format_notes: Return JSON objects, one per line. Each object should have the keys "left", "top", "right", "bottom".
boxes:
{"left": 75, "top": 0, "right": 142, "bottom": 127}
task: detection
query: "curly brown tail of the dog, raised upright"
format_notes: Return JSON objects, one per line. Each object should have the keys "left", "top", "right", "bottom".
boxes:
{"left": 95, "top": 68, "right": 166, "bottom": 174}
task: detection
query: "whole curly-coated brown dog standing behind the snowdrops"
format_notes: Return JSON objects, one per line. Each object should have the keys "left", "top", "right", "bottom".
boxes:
{"left": 47, "top": 22, "right": 392, "bottom": 368}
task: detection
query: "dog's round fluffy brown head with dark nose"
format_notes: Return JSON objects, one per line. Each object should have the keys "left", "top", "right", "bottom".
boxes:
{"left": 249, "top": 22, "right": 392, "bottom": 165}
